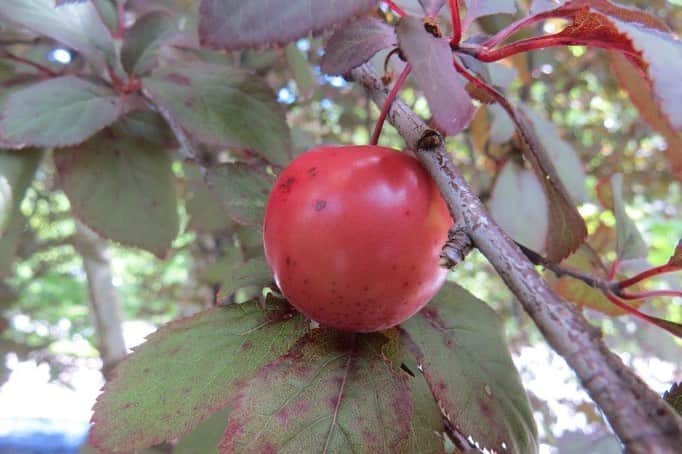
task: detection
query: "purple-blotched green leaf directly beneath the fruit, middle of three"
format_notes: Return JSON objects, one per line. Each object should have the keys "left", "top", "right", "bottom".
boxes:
{"left": 220, "top": 329, "right": 412, "bottom": 453}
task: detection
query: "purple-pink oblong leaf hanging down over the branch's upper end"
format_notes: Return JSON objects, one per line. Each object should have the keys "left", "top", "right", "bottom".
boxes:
{"left": 397, "top": 16, "right": 475, "bottom": 135}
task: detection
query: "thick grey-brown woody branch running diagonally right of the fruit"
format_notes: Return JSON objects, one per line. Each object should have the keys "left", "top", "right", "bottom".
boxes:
{"left": 351, "top": 65, "right": 682, "bottom": 453}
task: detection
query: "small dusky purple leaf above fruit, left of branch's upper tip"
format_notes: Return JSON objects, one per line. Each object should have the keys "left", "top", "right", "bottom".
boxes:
{"left": 321, "top": 17, "right": 398, "bottom": 75}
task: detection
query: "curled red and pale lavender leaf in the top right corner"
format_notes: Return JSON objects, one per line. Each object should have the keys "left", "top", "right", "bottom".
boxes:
{"left": 538, "top": 0, "right": 682, "bottom": 130}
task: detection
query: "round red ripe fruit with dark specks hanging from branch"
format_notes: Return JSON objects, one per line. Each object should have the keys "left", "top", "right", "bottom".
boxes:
{"left": 264, "top": 146, "right": 452, "bottom": 332}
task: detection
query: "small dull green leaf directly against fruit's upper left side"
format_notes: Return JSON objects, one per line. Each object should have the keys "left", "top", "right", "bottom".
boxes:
{"left": 208, "top": 164, "right": 274, "bottom": 225}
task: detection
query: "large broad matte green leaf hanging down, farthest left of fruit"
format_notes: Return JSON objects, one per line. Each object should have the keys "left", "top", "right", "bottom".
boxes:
{"left": 55, "top": 133, "right": 179, "bottom": 257}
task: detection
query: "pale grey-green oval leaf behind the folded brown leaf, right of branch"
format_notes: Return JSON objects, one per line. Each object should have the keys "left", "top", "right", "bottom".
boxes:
{"left": 488, "top": 160, "right": 550, "bottom": 251}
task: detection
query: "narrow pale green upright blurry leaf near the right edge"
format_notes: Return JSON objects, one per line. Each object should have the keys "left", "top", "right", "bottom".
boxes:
{"left": 598, "top": 173, "right": 649, "bottom": 260}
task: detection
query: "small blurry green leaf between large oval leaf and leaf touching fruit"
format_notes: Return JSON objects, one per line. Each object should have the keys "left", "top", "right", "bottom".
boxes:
{"left": 183, "top": 164, "right": 234, "bottom": 232}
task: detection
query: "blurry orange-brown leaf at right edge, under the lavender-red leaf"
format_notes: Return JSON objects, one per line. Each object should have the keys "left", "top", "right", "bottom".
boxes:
{"left": 609, "top": 52, "right": 682, "bottom": 181}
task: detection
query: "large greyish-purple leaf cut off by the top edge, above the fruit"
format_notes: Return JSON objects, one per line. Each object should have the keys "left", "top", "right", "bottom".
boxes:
{"left": 199, "top": 0, "right": 379, "bottom": 50}
